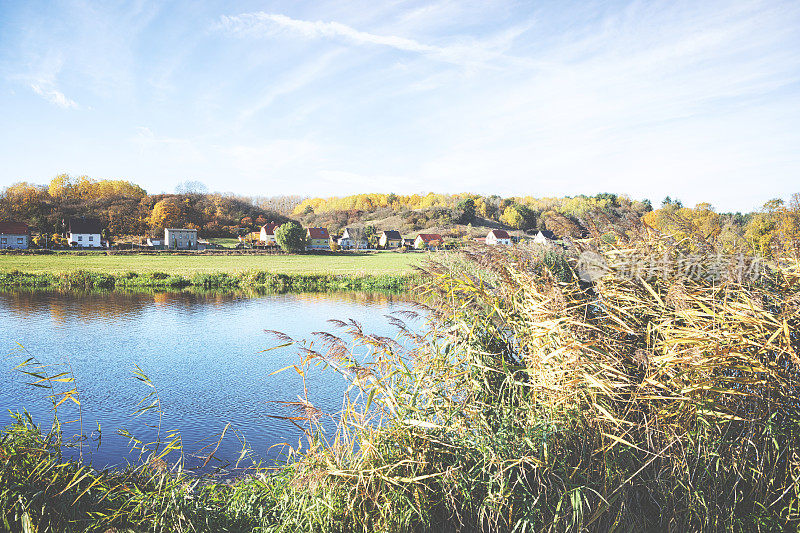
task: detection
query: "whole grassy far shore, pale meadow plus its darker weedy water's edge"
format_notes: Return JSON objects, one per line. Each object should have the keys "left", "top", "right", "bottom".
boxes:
{"left": 0, "top": 252, "right": 422, "bottom": 292}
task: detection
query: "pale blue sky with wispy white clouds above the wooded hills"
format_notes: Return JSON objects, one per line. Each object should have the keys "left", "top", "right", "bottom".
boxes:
{"left": 0, "top": 0, "right": 800, "bottom": 210}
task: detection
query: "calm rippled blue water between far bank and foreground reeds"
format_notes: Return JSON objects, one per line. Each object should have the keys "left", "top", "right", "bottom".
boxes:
{"left": 0, "top": 292, "right": 408, "bottom": 467}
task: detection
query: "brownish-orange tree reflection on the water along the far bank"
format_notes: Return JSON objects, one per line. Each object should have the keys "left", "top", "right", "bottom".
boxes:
{"left": 0, "top": 289, "right": 410, "bottom": 325}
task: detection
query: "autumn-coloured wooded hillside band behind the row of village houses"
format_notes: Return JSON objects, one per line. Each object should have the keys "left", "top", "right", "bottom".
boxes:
{"left": 0, "top": 174, "right": 800, "bottom": 256}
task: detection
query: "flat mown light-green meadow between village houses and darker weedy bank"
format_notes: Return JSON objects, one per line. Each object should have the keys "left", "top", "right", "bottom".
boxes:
{"left": 0, "top": 252, "right": 425, "bottom": 276}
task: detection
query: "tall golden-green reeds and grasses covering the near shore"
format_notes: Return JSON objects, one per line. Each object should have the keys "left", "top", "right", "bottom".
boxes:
{"left": 0, "top": 228, "right": 800, "bottom": 532}
